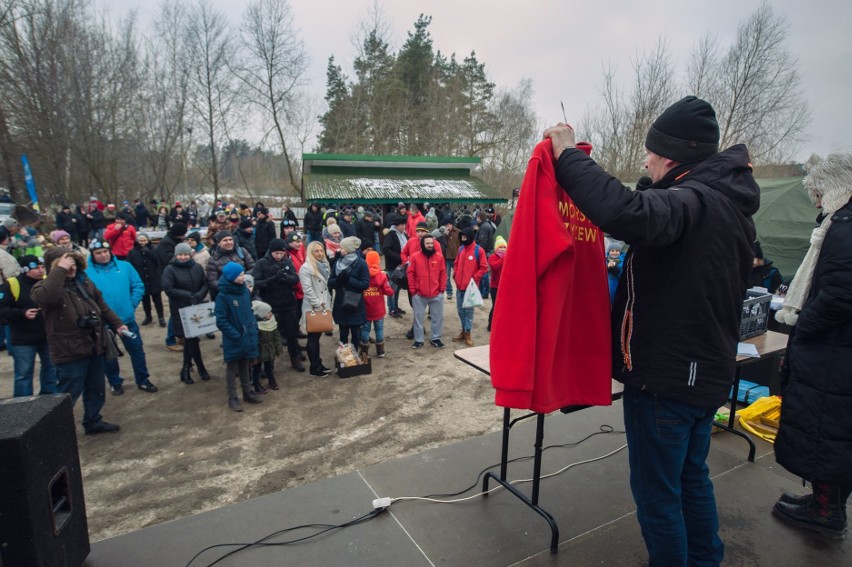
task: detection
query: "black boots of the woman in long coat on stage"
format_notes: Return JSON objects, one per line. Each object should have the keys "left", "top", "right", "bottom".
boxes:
{"left": 772, "top": 482, "right": 852, "bottom": 539}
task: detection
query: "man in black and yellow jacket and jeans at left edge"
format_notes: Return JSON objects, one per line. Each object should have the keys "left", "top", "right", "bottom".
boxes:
{"left": 0, "top": 255, "right": 56, "bottom": 398}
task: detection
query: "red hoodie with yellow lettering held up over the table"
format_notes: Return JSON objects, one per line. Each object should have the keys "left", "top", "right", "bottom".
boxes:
{"left": 490, "top": 139, "right": 612, "bottom": 413}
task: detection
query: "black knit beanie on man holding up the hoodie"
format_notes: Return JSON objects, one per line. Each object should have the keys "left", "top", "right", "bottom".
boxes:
{"left": 645, "top": 96, "right": 719, "bottom": 163}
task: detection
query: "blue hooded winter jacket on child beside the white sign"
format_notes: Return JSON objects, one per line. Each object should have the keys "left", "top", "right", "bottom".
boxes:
{"left": 216, "top": 276, "right": 258, "bottom": 362}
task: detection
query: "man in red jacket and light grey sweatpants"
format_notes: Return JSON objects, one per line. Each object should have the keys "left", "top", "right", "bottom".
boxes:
{"left": 408, "top": 234, "right": 447, "bottom": 349}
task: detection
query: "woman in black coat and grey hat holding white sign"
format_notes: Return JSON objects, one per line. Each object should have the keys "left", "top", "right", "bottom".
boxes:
{"left": 163, "top": 242, "right": 210, "bottom": 384}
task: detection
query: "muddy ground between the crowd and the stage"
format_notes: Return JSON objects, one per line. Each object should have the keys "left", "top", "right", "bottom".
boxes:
{"left": 0, "top": 292, "right": 502, "bottom": 541}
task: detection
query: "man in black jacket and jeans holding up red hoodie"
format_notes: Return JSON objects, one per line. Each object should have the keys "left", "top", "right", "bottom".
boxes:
{"left": 545, "top": 96, "right": 760, "bottom": 565}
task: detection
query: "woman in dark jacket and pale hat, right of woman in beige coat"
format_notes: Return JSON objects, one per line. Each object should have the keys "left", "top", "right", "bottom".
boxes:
{"left": 328, "top": 236, "right": 370, "bottom": 349}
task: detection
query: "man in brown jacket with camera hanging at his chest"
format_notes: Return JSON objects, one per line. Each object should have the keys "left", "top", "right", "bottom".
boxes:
{"left": 31, "top": 246, "right": 127, "bottom": 435}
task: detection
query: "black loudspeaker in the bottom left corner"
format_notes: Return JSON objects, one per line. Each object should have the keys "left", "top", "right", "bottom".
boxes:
{"left": 0, "top": 394, "right": 90, "bottom": 567}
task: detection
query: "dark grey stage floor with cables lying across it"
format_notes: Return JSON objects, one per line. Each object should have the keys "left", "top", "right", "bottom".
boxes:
{"left": 85, "top": 402, "right": 852, "bottom": 567}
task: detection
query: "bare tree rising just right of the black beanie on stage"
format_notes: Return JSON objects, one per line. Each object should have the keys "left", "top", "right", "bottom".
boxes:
{"left": 688, "top": 2, "right": 810, "bottom": 163}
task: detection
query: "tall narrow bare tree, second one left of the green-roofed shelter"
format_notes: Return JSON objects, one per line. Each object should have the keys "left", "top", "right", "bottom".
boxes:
{"left": 186, "top": 0, "right": 237, "bottom": 200}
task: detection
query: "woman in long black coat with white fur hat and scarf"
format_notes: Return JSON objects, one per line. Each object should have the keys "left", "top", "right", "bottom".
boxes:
{"left": 773, "top": 153, "right": 852, "bottom": 539}
